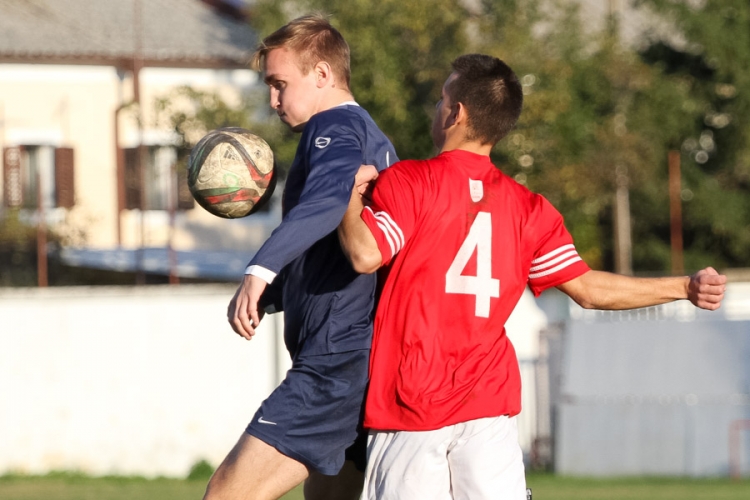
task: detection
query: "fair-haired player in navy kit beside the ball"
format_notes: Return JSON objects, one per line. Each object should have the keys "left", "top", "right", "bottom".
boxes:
{"left": 205, "top": 15, "right": 397, "bottom": 500}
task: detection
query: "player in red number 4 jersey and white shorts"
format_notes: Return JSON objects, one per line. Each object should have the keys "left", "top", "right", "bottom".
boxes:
{"left": 339, "top": 54, "right": 726, "bottom": 500}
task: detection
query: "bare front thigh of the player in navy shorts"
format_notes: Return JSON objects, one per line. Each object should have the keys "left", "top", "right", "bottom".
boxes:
{"left": 203, "top": 433, "right": 309, "bottom": 500}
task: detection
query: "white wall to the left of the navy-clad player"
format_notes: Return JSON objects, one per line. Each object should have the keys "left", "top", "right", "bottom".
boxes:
{"left": 0, "top": 285, "right": 288, "bottom": 476}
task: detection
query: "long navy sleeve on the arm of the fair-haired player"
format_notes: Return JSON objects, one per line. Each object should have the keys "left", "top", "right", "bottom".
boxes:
{"left": 250, "top": 115, "right": 363, "bottom": 273}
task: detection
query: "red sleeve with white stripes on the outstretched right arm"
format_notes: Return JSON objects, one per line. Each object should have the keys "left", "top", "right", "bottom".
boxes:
{"left": 529, "top": 196, "right": 590, "bottom": 296}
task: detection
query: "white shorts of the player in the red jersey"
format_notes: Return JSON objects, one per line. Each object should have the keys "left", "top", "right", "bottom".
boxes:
{"left": 362, "top": 417, "right": 526, "bottom": 500}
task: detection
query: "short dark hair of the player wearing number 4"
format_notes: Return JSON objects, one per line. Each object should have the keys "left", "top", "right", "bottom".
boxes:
{"left": 446, "top": 54, "right": 523, "bottom": 145}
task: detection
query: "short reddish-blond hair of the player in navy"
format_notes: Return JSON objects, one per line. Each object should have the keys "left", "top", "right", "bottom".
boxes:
{"left": 252, "top": 14, "right": 351, "bottom": 89}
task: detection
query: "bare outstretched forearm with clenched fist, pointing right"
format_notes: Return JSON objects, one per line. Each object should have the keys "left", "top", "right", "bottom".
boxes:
{"left": 557, "top": 267, "right": 727, "bottom": 311}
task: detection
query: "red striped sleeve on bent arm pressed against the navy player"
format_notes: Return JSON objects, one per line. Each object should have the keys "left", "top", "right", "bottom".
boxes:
{"left": 362, "top": 161, "right": 424, "bottom": 265}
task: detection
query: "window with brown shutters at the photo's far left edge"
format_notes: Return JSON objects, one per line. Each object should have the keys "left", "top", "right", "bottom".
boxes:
{"left": 3, "top": 145, "right": 75, "bottom": 209}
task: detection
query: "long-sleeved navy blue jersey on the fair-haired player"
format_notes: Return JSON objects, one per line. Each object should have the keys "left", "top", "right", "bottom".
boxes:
{"left": 250, "top": 104, "right": 398, "bottom": 358}
